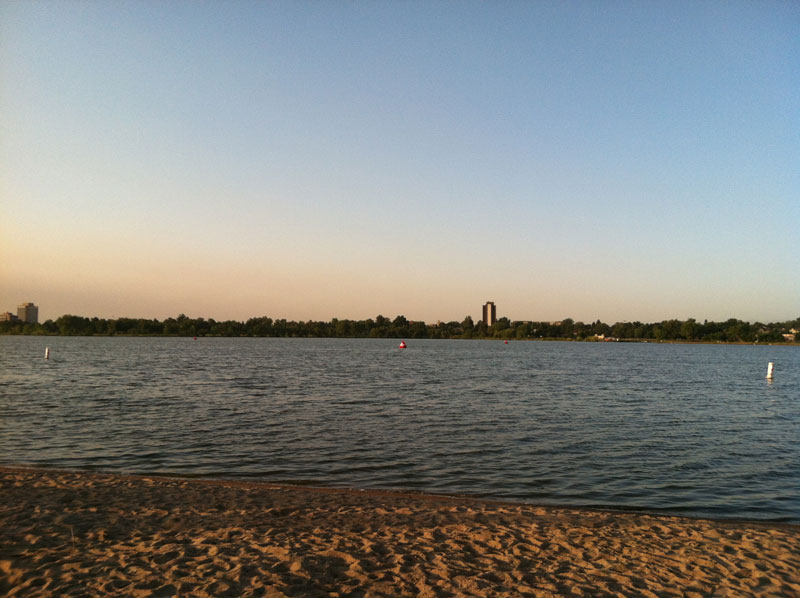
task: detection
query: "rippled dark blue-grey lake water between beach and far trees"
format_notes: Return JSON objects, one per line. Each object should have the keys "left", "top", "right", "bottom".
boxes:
{"left": 0, "top": 336, "right": 800, "bottom": 523}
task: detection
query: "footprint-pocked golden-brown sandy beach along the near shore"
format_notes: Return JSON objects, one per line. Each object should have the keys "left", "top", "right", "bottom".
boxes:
{"left": 0, "top": 467, "right": 800, "bottom": 597}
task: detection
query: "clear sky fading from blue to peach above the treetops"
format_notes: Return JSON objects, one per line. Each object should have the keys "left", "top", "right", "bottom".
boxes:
{"left": 0, "top": 0, "right": 800, "bottom": 323}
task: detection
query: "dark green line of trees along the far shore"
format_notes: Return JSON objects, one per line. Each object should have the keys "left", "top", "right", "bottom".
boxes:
{"left": 0, "top": 314, "right": 800, "bottom": 343}
